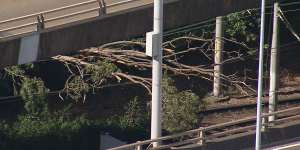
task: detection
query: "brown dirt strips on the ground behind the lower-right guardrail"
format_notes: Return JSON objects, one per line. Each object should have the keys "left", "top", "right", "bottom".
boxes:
{"left": 201, "top": 74, "right": 300, "bottom": 126}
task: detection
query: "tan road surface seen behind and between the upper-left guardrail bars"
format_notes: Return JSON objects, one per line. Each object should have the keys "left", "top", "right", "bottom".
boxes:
{"left": 0, "top": 0, "right": 153, "bottom": 37}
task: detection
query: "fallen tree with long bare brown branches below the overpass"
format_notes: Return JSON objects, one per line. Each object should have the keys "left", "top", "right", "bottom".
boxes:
{"left": 53, "top": 36, "right": 255, "bottom": 99}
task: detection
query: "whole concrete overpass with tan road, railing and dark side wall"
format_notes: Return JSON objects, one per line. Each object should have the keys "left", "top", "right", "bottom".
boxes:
{"left": 0, "top": 0, "right": 260, "bottom": 67}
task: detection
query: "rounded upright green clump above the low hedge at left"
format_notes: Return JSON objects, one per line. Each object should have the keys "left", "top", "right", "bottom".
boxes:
{"left": 20, "top": 78, "right": 49, "bottom": 116}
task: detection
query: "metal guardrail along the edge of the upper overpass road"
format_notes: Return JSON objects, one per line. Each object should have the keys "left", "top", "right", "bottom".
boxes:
{"left": 0, "top": 0, "right": 139, "bottom": 39}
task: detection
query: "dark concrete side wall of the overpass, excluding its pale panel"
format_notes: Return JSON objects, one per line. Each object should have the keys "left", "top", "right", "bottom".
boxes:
{"left": 0, "top": 0, "right": 260, "bottom": 67}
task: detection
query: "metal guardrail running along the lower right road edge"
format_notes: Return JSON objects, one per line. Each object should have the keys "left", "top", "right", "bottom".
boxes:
{"left": 108, "top": 106, "right": 300, "bottom": 150}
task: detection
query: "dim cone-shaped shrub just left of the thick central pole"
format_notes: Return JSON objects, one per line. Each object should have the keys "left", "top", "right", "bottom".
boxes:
{"left": 119, "top": 97, "right": 148, "bottom": 128}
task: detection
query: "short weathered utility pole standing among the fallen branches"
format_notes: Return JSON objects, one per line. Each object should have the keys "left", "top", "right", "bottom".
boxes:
{"left": 213, "top": 17, "right": 224, "bottom": 97}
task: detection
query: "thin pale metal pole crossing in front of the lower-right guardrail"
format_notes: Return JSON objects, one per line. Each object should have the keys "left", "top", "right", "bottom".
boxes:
{"left": 255, "top": 0, "right": 265, "bottom": 150}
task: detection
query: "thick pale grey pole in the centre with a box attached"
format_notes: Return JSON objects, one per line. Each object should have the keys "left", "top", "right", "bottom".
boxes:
{"left": 151, "top": 0, "right": 163, "bottom": 147}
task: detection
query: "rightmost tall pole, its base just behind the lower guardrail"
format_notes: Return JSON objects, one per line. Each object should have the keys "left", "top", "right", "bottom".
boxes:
{"left": 269, "top": 2, "right": 279, "bottom": 122}
